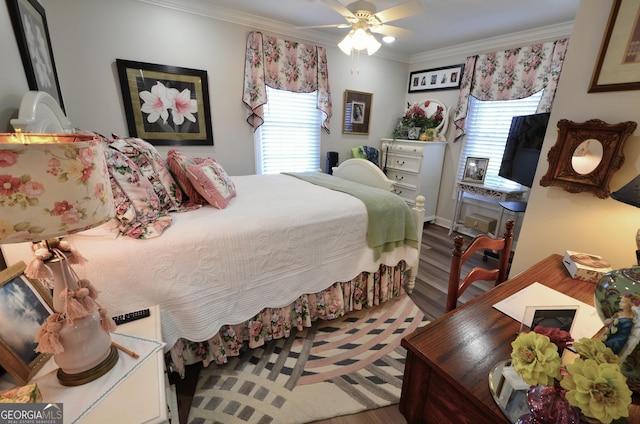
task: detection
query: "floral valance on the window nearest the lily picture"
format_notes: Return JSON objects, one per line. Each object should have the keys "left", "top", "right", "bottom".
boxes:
{"left": 242, "top": 31, "right": 331, "bottom": 133}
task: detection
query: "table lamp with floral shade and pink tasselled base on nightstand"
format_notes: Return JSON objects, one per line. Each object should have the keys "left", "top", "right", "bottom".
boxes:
{"left": 0, "top": 133, "right": 118, "bottom": 386}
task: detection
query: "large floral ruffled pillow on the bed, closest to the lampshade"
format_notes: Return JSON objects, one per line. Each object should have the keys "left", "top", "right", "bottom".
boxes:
{"left": 104, "top": 146, "right": 172, "bottom": 239}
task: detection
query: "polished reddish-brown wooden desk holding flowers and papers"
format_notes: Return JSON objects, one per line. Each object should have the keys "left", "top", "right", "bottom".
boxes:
{"left": 400, "top": 255, "right": 640, "bottom": 424}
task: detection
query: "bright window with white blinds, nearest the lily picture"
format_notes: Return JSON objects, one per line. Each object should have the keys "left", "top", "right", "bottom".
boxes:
{"left": 254, "top": 87, "right": 322, "bottom": 174}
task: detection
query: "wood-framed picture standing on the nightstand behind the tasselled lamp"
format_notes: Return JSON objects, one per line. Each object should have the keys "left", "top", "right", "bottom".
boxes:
{"left": 0, "top": 262, "right": 53, "bottom": 385}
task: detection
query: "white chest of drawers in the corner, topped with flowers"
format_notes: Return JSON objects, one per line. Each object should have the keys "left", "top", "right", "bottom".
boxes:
{"left": 380, "top": 138, "right": 447, "bottom": 222}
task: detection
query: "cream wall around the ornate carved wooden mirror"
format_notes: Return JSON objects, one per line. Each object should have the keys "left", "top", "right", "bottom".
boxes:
{"left": 512, "top": 0, "right": 640, "bottom": 272}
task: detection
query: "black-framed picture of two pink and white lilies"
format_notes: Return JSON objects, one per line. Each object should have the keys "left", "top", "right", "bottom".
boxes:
{"left": 116, "top": 59, "right": 213, "bottom": 146}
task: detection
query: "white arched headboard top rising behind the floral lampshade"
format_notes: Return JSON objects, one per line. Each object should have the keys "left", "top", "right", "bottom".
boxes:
{"left": 11, "top": 91, "right": 74, "bottom": 134}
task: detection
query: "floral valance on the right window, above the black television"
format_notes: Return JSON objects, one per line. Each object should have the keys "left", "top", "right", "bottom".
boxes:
{"left": 453, "top": 38, "right": 569, "bottom": 141}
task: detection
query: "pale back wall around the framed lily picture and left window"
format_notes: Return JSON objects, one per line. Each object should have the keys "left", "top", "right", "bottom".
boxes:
{"left": 31, "top": 0, "right": 408, "bottom": 175}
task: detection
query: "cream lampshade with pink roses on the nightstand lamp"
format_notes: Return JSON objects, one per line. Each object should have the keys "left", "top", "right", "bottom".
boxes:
{"left": 0, "top": 133, "right": 114, "bottom": 244}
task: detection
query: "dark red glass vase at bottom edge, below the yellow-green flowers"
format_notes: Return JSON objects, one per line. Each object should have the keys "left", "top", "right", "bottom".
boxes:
{"left": 516, "top": 386, "right": 581, "bottom": 424}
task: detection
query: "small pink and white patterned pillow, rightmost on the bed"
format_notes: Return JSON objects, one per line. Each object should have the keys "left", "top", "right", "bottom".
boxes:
{"left": 187, "top": 159, "right": 236, "bottom": 209}
